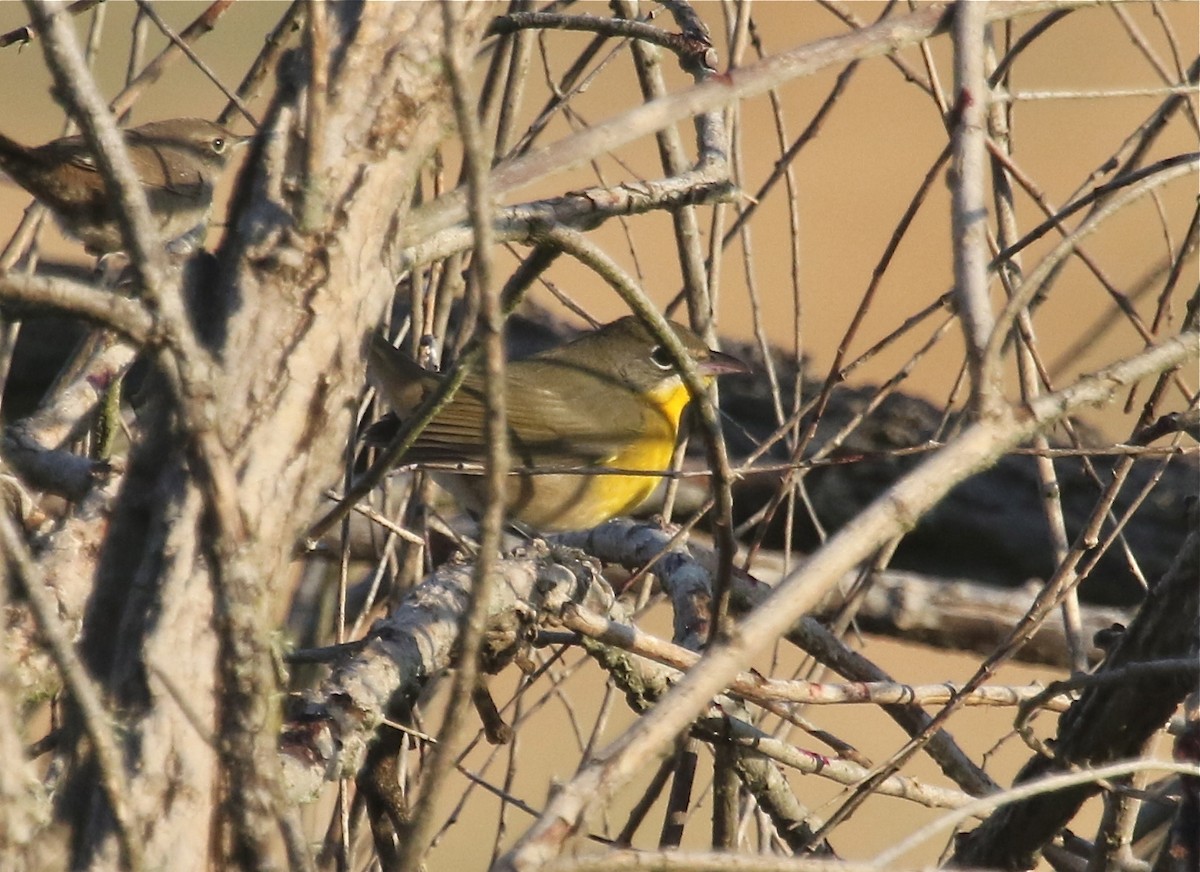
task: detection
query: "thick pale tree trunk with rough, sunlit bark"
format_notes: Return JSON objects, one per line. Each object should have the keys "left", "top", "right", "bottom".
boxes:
{"left": 49, "top": 4, "right": 487, "bottom": 871}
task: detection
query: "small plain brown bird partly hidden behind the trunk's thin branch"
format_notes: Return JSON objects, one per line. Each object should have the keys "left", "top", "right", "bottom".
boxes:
{"left": 0, "top": 118, "right": 250, "bottom": 255}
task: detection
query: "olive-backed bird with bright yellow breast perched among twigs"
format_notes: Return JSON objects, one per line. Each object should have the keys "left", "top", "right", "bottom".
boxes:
{"left": 368, "top": 315, "right": 748, "bottom": 530}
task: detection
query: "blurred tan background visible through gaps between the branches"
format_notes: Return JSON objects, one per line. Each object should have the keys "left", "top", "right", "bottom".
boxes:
{"left": 0, "top": 0, "right": 1200, "bottom": 868}
